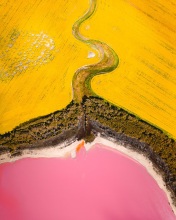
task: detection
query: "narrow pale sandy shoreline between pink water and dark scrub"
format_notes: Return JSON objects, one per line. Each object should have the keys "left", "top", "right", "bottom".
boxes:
{"left": 0, "top": 134, "right": 176, "bottom": 215}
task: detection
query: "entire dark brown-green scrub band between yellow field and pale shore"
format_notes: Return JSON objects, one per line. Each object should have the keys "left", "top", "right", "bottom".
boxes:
{"left": 0, "top": 97, "right": 176, "bottom": 196}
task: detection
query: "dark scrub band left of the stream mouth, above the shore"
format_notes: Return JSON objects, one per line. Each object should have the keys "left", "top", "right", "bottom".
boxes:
{"left": 0, "top": 102, "right": 82, "bottom": 155}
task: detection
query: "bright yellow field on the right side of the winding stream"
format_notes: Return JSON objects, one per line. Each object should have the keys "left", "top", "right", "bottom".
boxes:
{"left": 84, "top": 0, "right": 176, "bottom": 138}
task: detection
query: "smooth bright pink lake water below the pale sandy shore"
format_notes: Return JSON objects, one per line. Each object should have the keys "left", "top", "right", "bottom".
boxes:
{"left": 0, "top": 144, "right": 176, "bottom": 220}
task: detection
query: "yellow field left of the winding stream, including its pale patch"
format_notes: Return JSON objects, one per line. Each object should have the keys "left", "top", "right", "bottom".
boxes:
{"left": 0, "top": 0, "right": 98, "bottom": 133}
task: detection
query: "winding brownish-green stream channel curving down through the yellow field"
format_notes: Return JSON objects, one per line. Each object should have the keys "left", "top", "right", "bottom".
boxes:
{"left": 72, "top": 0, "right": 119, "bottom": 103}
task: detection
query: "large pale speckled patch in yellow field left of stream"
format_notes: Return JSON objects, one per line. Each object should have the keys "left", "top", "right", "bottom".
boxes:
{"left": 0, "top": 29, "right": 56, "bottom": 80}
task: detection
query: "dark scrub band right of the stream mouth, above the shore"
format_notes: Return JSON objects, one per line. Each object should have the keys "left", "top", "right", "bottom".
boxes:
{"left": 83, "top": 97, "right": 176, "bottom": 196}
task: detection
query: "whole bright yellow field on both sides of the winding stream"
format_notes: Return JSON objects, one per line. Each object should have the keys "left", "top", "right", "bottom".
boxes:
{"left": 0, "top": 0, "right": 176, "bottom": 138}
